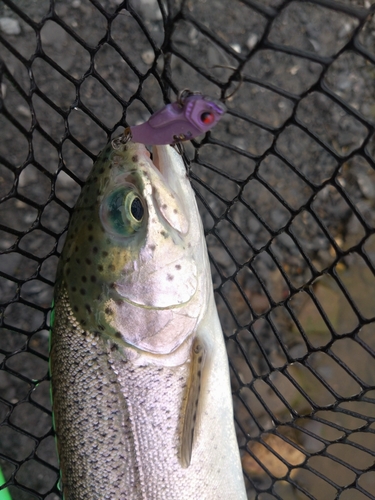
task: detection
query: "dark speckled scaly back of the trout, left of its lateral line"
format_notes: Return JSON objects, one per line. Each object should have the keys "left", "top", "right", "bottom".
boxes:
{"left": 51, "top": 292, "right": 134, "bottom": 500}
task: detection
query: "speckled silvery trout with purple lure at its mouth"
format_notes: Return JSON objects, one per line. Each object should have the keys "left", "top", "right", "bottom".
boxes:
{"left": 50, "top": 137, "right": 247, "bottom": 500}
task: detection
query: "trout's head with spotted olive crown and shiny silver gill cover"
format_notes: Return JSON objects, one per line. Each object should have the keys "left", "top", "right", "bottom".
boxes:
{"left": 57, "top": 137, "right": 211, "bottom": 354}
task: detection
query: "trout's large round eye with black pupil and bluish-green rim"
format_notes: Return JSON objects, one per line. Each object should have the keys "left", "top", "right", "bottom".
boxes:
{"left": 100, "top": 185, "right": 145, "bottom": 236}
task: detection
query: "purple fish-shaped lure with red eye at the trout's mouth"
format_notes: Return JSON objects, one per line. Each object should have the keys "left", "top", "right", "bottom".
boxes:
{"left": 129, "top": 91, "right": 226, "bottom": 145}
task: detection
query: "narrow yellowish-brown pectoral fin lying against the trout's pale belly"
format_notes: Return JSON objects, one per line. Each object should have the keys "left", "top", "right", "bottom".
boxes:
{"left": 180, "top": 338, "right": 206, "bottom": 469}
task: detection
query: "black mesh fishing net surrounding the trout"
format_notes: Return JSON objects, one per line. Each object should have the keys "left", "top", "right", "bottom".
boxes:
{"left": 0, "top": 0, "right": 375, "bottom": 500}
